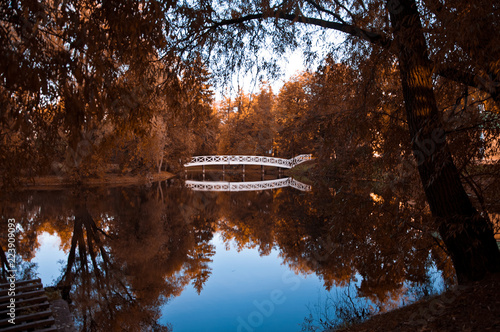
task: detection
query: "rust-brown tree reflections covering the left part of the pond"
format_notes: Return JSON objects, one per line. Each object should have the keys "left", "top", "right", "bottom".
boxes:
{"left": 0, "top": 184, "right": 214, "bottom": 331}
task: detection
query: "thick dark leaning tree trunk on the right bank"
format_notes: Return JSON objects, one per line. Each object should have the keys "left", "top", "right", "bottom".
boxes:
{"left": 388, "top": 0, "right": 500, "bottom": 283}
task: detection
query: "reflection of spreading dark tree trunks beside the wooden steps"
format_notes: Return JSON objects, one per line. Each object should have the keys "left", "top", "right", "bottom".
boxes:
{"left": 57, "top": 197, "right": 164, "bottom": 331}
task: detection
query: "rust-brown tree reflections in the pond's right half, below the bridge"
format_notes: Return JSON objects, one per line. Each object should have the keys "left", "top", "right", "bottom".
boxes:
{"left": 213, "top": 179, "right": 454, "bottom": 308}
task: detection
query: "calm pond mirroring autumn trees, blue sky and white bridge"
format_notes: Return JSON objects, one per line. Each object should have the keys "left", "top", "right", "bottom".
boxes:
{"left": 2, "top": 174, "right": 453, "bottom": 332}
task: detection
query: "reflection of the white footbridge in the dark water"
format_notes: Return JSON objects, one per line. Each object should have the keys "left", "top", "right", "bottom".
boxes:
{"left": 186, "top": 178, "right": 311, "bottom": 191}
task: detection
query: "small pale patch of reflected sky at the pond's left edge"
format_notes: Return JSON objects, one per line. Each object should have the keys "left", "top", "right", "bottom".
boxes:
{"left": 31, "top": 232, "right": 67, "bottom": 286}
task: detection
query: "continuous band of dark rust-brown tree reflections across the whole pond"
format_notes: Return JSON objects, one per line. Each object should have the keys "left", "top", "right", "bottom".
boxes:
{"left": 1, "top": 174, "right": 454, "bottom": 331}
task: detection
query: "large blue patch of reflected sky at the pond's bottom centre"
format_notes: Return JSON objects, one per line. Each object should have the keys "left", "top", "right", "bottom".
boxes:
{"left": 160, "top": 234, "right": 332, "bottom": 332}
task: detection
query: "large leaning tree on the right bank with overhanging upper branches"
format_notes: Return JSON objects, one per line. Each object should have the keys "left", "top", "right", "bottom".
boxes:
{"left": 170, "top": 0, "right": 500, "bottom": 282}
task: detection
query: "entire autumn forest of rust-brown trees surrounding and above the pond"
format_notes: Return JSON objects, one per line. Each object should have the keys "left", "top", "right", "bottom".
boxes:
{"left": 0, "top": 0, "right": 500, "bottom": 290}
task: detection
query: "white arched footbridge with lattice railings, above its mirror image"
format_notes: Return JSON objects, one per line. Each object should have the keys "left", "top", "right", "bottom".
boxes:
{"left": 184, "top": 154, "right": 313, "bottom": 168}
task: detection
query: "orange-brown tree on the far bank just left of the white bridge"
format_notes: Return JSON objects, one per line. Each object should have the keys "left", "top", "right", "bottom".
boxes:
{"left": 107, "top": 59, "right": 218, "bottom": 172}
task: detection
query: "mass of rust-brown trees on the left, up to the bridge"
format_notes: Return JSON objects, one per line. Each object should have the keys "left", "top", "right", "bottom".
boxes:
{"left": 0, "top": 0, "right": 215, "bottom": 184}
